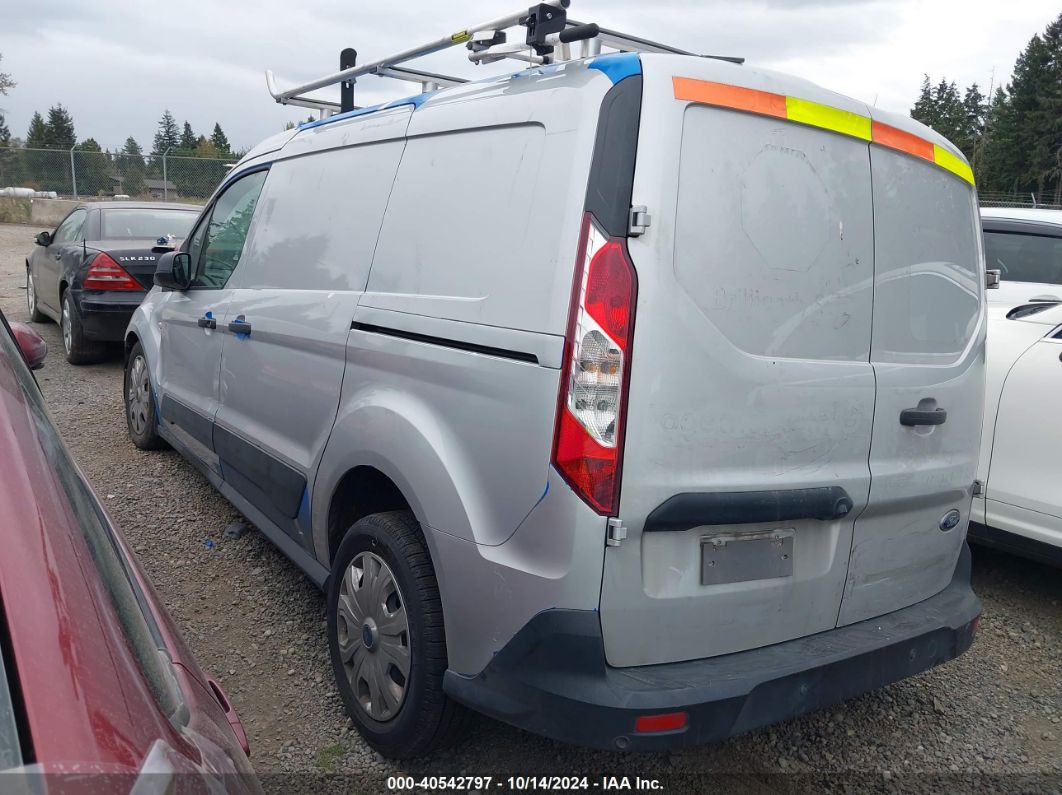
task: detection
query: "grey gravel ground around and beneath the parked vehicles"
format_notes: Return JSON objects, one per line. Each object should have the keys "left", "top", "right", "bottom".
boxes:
{"left": 0, "top": 218, "right": 1062, "bottom": 793}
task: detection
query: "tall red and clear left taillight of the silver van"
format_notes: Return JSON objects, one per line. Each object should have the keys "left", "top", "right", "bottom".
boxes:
{"left": 553, "top": 212, "right": 637, "bottom": 515}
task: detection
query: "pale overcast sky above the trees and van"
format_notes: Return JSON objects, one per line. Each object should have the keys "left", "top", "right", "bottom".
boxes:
{"left": 0, "top": 0, "right": 1060, "bottom": 150}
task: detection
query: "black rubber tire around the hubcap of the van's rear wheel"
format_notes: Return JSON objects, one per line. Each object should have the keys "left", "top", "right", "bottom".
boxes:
{"left": 326, "top": 511, "right": 467, "bottom": 759}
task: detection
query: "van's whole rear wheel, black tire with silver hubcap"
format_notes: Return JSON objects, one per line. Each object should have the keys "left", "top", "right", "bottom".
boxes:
{"left": 327, "top": 511, "right": 464, "bottom": 758}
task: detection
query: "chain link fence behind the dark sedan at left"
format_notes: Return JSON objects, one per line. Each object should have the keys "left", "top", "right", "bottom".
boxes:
{"left": 0, "top": 148, "right": 236, "bottom": 204}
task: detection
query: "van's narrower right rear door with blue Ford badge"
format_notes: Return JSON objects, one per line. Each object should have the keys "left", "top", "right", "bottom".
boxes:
{"left": 839, "top": 110, "right": 986, "bottom": 624}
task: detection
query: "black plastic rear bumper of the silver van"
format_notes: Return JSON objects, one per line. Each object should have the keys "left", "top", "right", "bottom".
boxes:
{"left": 445, "top": 545, "right": 981, "bottom": 750}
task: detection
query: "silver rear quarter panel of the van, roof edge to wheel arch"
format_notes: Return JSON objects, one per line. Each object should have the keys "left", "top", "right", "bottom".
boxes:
{"left": 329, "top": 64, "right": 612, "bottom": 547}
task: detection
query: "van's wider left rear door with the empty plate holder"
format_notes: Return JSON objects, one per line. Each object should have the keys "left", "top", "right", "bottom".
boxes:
{"left": 601, "top": 56, "right": 874, "bottom": 667}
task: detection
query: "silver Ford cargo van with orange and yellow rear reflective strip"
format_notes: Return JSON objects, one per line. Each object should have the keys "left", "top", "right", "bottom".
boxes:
{"left": 125, "top": 15, "right": 986, "bottom": 756}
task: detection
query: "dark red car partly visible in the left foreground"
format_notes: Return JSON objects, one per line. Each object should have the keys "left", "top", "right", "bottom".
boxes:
{"left": 0, "top": 314, "right": 260, "bottom": 793}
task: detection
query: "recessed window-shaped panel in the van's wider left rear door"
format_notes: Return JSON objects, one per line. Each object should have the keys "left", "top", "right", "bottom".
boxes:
{"left": 674, "top": 105, "right": 873, "bottom": 361}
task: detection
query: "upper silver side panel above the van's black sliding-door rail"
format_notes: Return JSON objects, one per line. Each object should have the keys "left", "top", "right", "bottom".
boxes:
{"left": 364, "top": 64, "right": 611, "bottom": 335}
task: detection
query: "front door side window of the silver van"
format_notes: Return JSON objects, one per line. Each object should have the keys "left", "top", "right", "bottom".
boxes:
{"left": 188, "top": 171, "right": 267, "bottom": 290}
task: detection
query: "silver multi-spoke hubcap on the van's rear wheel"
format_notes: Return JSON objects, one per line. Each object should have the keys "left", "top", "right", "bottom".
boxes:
{"left": 337, "top": 552, "right": 410, "bottom": 722}
